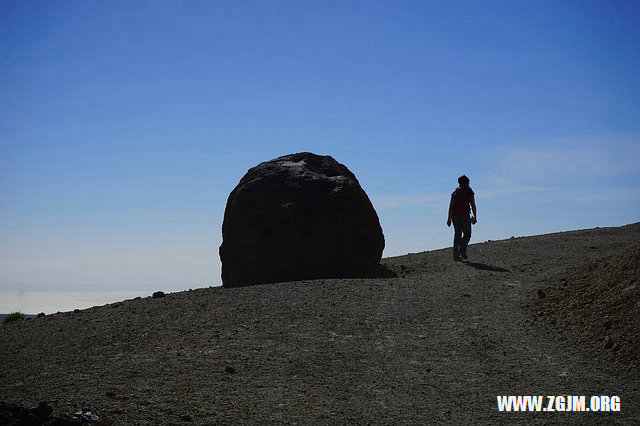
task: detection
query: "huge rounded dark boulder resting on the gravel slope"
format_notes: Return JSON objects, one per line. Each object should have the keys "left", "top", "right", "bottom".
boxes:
{"left": 220, "top": 152, "right": 384, "bottom": 287}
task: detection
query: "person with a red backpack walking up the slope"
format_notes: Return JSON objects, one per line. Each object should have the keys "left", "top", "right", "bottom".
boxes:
{"left": 447, "top": 175, "right": 478, "bottom": 262}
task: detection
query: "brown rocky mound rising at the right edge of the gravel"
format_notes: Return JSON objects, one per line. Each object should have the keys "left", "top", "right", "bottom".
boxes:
{"left": 539, "top": 242, "right": 640, "bottom": 377}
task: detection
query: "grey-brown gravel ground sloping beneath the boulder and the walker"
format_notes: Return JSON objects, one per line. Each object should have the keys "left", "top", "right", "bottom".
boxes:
{"left": 0, "top": 223, "right": 640, "bottom": 424}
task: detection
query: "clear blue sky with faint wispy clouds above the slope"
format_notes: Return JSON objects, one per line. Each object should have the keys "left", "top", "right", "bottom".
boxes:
{"left": 0, "top": 0, "right": 640, "bottom": 290}
